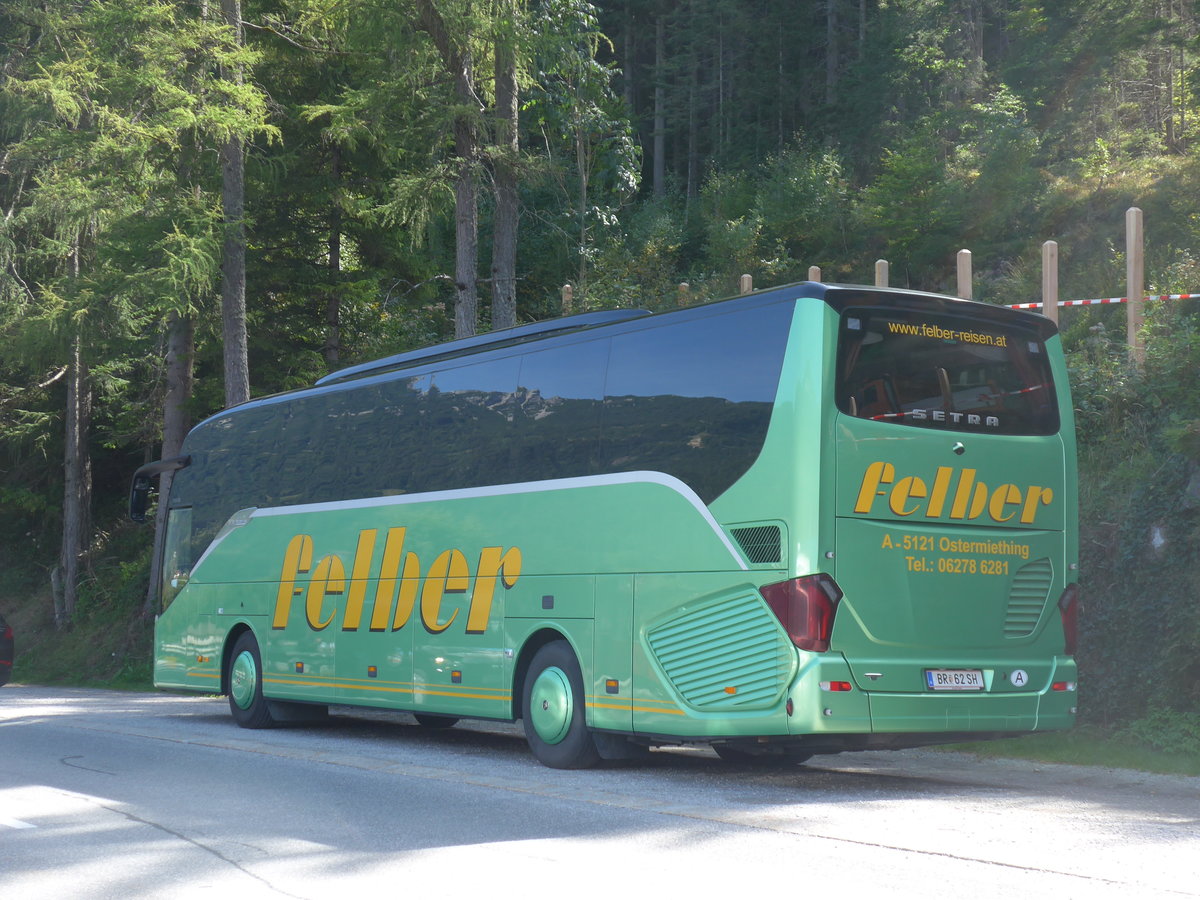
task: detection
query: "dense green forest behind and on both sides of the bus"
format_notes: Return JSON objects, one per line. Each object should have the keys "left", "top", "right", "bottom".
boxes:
{"left": 0, "top": 0, "right": 1200, "bottom": 757}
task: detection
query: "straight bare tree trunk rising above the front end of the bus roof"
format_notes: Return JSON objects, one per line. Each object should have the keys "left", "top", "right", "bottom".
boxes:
{"left": 221, "top": 0, "right": 250, "bottom": 407}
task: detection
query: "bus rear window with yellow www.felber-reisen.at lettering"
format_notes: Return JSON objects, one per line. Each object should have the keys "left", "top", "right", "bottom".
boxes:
{"left": 836, "top": 308, "right": 1058, "bottom": 434}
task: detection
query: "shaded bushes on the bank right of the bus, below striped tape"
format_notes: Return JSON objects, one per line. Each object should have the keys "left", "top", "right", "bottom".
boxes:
{"left": 1070, "top": 304, "right": 1200, "bottom": 722}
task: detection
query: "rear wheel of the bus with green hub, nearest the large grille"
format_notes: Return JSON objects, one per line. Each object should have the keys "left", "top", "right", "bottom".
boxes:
{"left": 521, "top": 641, "right": 600, "bottom": 769}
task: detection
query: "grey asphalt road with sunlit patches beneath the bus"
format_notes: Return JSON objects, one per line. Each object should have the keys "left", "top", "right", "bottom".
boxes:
{"left": 0, "top": 685, "right": 1200, "bottom": 900}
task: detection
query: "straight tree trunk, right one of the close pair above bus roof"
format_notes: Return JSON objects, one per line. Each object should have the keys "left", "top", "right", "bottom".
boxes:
{"left": 492, "top": 6, "right": 521, "bottom": 329}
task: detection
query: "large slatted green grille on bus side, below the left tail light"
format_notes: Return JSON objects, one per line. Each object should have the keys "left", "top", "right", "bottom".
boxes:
{"left": 646, "top": 592, "right": 796, "bottom": 710}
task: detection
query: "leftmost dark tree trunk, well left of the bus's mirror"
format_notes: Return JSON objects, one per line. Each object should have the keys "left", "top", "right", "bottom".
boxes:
{"left": 54, "top": 335, "right": 91, "bottom": 629}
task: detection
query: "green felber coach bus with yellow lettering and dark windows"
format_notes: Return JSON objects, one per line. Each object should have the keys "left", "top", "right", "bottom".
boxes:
{"left": 131, "top": 283, "right": 1079, "bottom": 768}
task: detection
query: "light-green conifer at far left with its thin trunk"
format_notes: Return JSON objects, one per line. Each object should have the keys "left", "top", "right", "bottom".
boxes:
{"left": 0, "top": 0, "right": 270, "bottom": 625}
